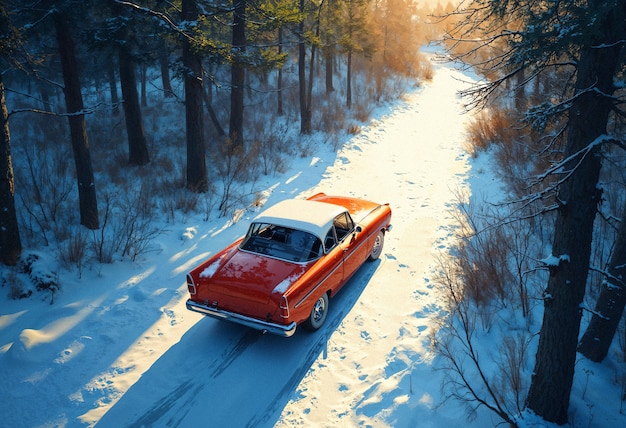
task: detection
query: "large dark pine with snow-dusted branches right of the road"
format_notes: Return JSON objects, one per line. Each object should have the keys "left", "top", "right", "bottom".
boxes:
{"left": 444, "top": 0, "right": 626, "bottom": 424}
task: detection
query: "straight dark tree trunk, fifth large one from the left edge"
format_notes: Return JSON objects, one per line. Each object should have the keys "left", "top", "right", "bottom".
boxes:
{"left": 228, "top": 0, "right": 246, "bottom": 148}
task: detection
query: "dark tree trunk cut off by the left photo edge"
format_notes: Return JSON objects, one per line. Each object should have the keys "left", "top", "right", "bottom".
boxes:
{"left": 0, "top": 73, "right": 22, "bottom": 266}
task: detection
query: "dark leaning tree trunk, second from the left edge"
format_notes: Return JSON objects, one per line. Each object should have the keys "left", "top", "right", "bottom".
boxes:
{"left": 54, "top": 13, "right": 100, "bottom": 229}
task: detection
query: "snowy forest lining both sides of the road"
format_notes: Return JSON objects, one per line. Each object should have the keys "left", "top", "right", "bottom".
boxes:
{"left": 0, "top": 0, "right": 626, "bottom": 427}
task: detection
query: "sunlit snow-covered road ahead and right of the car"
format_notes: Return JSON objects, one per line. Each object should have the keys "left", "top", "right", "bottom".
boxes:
{"left": 278, "top": 58, "right": 476, "bottom": 427}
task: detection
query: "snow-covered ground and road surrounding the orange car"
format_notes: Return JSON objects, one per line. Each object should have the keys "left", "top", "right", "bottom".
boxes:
{"left": 0, "top": 51, "right": 625, "bottom": 428}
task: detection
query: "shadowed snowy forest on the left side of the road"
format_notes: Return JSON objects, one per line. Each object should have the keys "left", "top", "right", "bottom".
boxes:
{"left": 0, "top": 0, "right": 438, "bottom": 265}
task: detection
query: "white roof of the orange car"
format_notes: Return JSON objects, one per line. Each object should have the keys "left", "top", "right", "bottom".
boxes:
{"left": 253, "top": 199, "right": 348, "bottom": 241}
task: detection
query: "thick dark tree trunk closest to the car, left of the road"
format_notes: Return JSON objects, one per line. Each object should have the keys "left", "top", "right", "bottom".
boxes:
{"left": 182, "top": 0, "right": 209, "bottom": 193}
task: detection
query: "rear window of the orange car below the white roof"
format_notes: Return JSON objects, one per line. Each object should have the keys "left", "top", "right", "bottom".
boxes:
{"left": 241, "top": 223, "right": 322, "bottom": 262}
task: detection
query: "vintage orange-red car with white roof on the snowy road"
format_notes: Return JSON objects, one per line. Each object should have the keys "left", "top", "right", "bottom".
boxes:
{"left": 187, "top": 193, "right": 391, "bottom": 337}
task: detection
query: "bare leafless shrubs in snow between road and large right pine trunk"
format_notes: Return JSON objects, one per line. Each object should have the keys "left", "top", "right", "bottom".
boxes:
{"left": 432, "top": 197, "right": 532, "bottom": 426}
